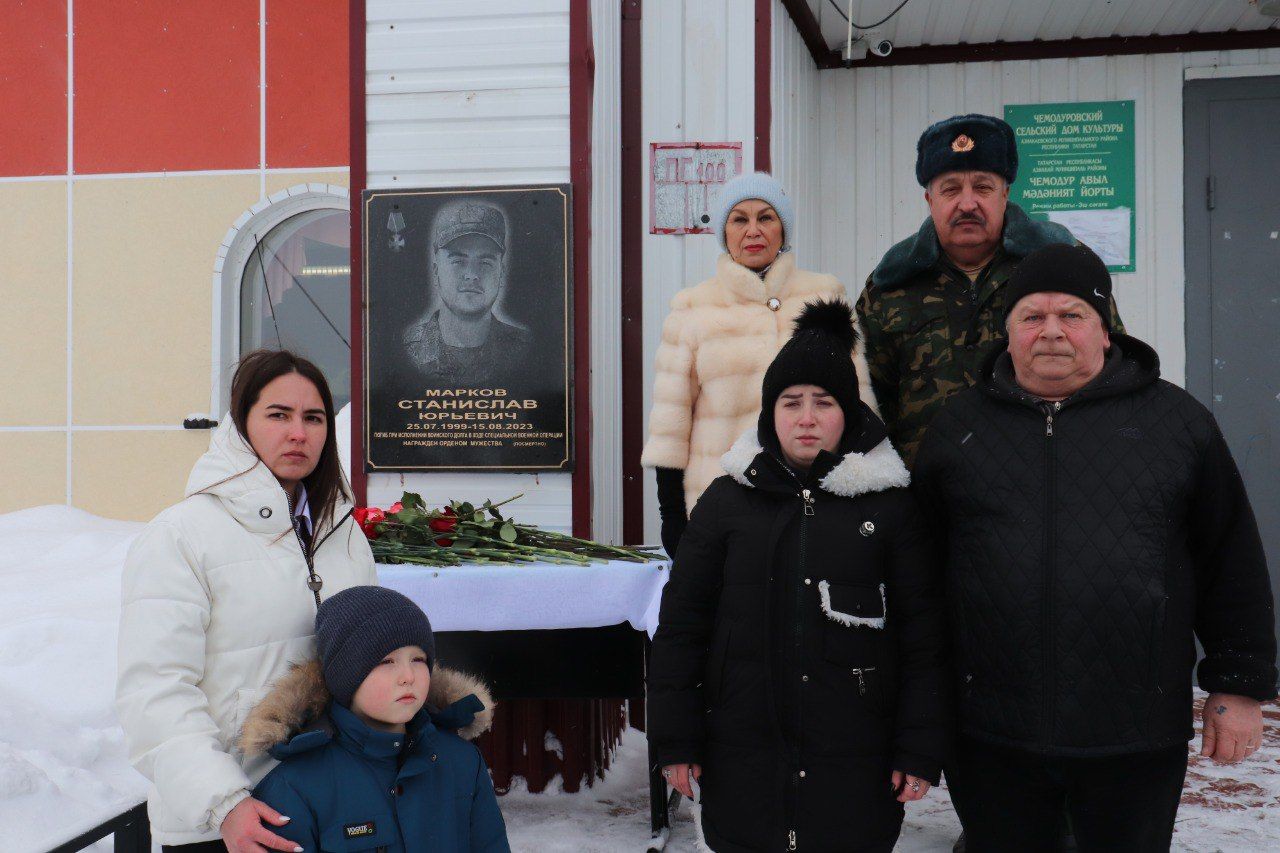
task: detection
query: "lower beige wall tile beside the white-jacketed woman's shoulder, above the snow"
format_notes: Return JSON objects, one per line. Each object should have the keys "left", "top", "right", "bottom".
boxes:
{"left": 72, "top": 429, "right": 209, "bottom": 521}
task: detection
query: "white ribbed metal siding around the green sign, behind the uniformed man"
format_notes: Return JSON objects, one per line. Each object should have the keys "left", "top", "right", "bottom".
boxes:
{"left": 814, "top": 50, "right": 1280, "bottom": 384}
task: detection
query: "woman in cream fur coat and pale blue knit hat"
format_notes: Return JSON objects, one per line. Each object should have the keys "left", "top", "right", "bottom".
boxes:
{"left": 640, "top": 172, "right": 878, "bottom": 556}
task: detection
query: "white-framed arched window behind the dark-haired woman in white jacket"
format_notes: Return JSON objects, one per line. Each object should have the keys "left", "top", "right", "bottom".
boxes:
{"left": 219, "top": 184, "right": 351, "bottom": 411}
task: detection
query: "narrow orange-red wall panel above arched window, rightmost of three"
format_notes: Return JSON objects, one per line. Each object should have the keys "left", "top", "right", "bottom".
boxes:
{"left": 266, "top": 0, "right": 351, "bottom": 169}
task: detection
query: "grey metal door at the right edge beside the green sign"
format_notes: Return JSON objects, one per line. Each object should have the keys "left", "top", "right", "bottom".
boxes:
{"left": 1185, "top": 77, "right": 1280, "bottom": 655}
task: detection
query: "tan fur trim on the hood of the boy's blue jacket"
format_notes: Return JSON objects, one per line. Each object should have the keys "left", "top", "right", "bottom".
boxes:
{"left": 239, "top": 661, "right": 494, "bottom": 756}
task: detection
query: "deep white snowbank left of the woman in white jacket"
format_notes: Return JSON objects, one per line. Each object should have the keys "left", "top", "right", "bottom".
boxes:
{"left": 0, "top": 506, "right": 147, "bottom": 852}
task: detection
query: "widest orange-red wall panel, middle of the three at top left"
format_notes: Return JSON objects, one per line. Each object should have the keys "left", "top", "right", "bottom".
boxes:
{"left": 74, "top": 0, "right": 260, "bottom": 173}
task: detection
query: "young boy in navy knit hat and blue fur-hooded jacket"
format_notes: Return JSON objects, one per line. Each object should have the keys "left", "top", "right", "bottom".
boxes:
{"left": 241, "top": 587, "right": 511, "bottom": 853}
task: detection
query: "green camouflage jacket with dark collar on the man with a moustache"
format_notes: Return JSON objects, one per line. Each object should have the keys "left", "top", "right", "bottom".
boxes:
{"left": 856, "top": 202, "right": 1124, "bottom": 466}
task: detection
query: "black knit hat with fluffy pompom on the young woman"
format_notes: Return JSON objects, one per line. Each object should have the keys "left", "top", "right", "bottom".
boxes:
{"left": 756, "top": 300, "right": 859, "bottom": 447}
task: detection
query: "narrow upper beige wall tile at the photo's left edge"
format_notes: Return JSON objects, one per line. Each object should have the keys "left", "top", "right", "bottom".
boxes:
{"left": 0, "top": 181, "right": 67, "bottom": 427}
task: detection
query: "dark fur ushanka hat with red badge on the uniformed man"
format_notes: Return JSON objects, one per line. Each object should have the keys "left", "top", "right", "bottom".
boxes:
{"left": 915, "top": 113, "right": 1018, "bottom": 187}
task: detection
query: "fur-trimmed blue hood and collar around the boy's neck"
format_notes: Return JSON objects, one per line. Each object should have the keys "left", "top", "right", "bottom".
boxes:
{"left": 239, "top": 661, "right": 494, "bottom": 761}
